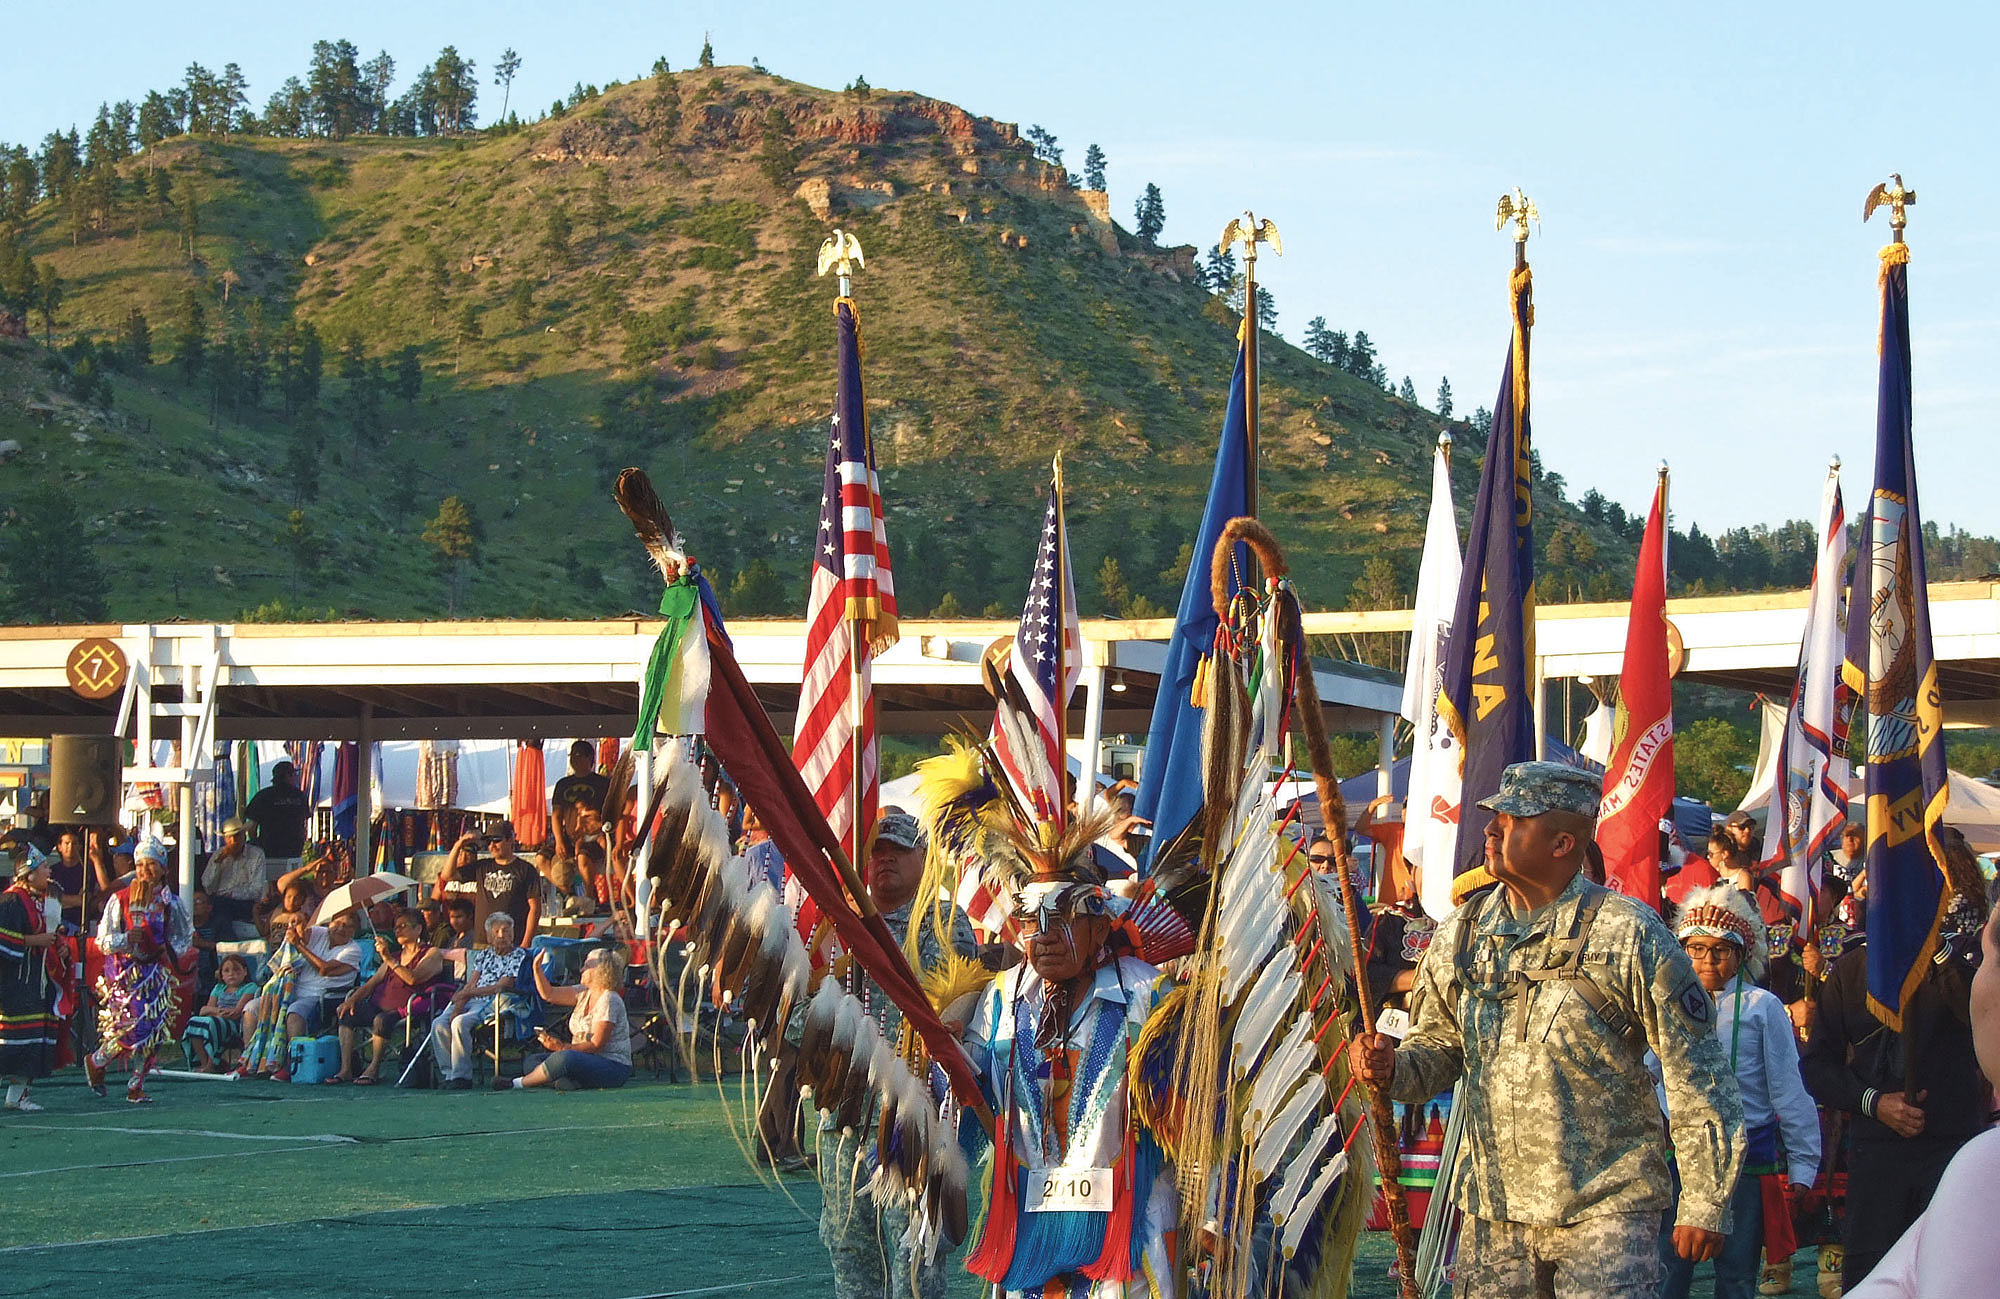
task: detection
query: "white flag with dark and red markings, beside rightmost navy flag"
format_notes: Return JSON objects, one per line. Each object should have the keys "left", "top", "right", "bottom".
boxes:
{"left": 1762, "top": 460, "right": 1848, "bottom": 919}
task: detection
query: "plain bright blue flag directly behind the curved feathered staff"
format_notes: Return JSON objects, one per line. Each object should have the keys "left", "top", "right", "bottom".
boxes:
{"left": 1132, "top": 348, "right": 1250, "bottom": 865}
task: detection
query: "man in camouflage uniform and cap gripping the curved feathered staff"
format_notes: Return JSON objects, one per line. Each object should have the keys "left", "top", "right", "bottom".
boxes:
{"left": 1352, "top": 761, "right": 1742, "bottom": 1299}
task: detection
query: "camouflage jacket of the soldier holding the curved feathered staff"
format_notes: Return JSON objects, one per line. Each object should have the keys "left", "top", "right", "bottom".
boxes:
{"left": 1390, "top": 875, "right": 1742, "bottom": 1231}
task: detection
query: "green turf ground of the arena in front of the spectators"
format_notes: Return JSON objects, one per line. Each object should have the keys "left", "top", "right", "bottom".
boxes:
{"left": 0, "top": 1071, "right": 1814, "bottom": 1299}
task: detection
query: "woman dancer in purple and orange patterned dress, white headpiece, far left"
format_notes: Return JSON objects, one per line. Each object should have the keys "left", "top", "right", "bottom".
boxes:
{"left": 84, "top": 839, "right": 194, "bottom": 1105}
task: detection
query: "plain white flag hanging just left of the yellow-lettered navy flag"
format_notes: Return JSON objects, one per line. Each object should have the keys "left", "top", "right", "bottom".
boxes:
{"left": 1402, "top": 444, "right": 1462, "bottom": 917}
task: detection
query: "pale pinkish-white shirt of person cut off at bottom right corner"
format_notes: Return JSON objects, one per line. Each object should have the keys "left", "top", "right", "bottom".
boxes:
{"left": 1848, "top": 1129, "right": 2000, "bottom": 1299}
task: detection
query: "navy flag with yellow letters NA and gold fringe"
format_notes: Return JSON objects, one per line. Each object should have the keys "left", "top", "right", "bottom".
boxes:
{"left": 1438, "top": 266, "right": 1534, "bottom": 901}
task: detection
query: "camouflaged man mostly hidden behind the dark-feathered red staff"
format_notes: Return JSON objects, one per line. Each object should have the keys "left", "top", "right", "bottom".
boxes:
{"left": 820, "top": 811, "right": 980, "bottom": 1299}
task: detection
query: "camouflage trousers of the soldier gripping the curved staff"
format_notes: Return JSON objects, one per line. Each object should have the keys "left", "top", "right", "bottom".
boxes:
{"left": 1452, "top": 1211, "right": 1664, "bottom": 1299}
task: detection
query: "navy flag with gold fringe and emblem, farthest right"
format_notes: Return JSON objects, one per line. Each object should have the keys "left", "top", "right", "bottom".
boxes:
{"left": 1840, "top": 242, "right": 1950, "bottom": 1031}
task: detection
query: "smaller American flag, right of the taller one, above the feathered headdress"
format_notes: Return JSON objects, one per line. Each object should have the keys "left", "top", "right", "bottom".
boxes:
{"left": 958, "top": 476, "right": 1084, "bottom": 933}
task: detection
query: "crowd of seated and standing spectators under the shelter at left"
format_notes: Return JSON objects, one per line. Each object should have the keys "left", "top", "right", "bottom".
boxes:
{"left": 0, "top": 741, "right": 652, "bottom": 1111}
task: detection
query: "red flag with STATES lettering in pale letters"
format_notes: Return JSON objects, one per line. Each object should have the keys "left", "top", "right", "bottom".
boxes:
{"left": 1598, "top": 470, "right": 1674, "bottom": 909}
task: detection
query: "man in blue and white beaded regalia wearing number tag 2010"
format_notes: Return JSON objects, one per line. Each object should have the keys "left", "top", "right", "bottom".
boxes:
{"left": 966, "top": 825, "right": 1180, "bottom": 1299}
